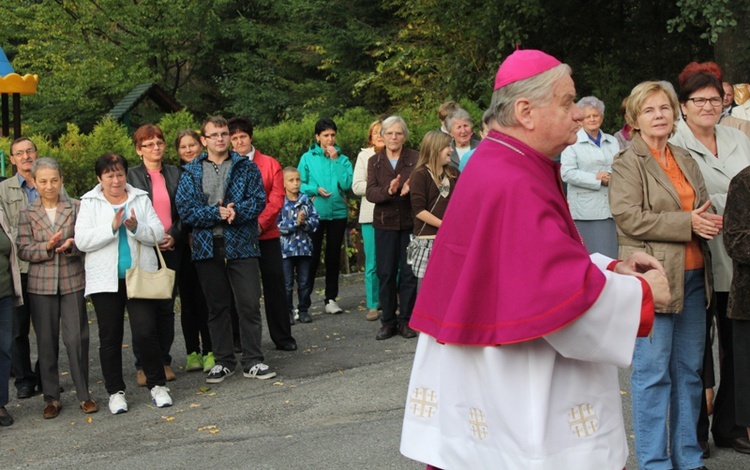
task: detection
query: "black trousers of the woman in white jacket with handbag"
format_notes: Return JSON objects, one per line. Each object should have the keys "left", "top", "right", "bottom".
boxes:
{"left": 91, "top": 279, "right": 167, "bottom": 395}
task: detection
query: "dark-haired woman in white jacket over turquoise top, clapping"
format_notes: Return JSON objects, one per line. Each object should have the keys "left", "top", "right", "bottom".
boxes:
{"left": 75, "top": 153, "right": 172, "bottom": 414}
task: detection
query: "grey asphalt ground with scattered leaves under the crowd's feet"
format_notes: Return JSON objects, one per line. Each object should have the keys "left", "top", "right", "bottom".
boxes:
{"left": 0, "top": 274, "right": 750, "bottom": 470}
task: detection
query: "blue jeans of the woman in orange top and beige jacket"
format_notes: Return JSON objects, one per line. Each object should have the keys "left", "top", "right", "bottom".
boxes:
{"left": 630, "top": 269, "right": 706, "bottom": 470}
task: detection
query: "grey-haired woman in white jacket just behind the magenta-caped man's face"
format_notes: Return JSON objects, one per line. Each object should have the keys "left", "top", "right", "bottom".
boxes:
{"left": 560, "top": 96, "right": 620, "bottom": 259}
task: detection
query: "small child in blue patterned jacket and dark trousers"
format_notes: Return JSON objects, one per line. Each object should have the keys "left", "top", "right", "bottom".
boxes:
{"left": 277, "top": 167, "right": 320, "bottom": 324}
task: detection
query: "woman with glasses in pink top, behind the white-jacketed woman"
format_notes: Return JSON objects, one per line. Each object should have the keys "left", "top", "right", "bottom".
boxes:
{"left": 128, "top": 124, "right": 185, "bottom": 387}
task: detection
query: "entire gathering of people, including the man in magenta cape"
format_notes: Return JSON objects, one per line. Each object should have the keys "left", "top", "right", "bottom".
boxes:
{"left": 0, "top": 47, "right": 750, "bottom": 469}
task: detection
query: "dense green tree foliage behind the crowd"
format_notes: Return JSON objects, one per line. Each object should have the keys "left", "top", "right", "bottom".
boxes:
{"left": 0, "top": 0, "right": 750, "bottom": 139}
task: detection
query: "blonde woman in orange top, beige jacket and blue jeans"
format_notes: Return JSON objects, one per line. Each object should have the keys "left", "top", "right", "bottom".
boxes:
{"left": 609, "top": 82, "right": 722, "bottom": 469}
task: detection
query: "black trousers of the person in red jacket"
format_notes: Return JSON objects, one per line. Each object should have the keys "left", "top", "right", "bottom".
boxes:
{"left": 258, "top": 238, "right": 296, "bottom": 346}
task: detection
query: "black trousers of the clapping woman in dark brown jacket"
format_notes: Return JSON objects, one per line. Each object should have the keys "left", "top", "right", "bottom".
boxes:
{"left": 375, "top": 229, "right": 417, "bottom": 326}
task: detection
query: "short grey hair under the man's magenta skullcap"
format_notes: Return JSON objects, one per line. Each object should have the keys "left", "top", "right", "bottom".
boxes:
{"left": 488, "top": 64, "right": 573, "bottom": 127}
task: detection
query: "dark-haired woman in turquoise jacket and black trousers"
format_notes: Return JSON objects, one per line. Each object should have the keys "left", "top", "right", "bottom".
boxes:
{"left": 298, "top": 118, "right": 353, "bottom": 314}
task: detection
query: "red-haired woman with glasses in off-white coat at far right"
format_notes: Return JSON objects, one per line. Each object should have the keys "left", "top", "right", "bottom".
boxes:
{"left": 670, "top": 62, "right": 750, "bottom": 454}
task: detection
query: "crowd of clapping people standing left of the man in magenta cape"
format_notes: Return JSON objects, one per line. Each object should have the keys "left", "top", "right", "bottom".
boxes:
{"left": 0, "top": 108, "right": 470, "bottom": 425}
